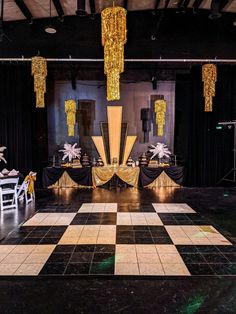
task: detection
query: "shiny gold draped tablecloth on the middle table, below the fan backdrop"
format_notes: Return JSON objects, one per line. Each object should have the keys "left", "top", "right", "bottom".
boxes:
{"left": 92, "top": 166, "right": 139, "bottom": 187}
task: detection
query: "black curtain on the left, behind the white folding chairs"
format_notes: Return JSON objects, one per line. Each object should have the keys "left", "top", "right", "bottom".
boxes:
{"left": 0, "top": 64, "right": 47, "bottom": 182}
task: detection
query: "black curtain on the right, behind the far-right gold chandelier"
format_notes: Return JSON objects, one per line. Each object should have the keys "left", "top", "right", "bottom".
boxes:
{"left": 175, "top": 66, "right": 236, "bottom": 186}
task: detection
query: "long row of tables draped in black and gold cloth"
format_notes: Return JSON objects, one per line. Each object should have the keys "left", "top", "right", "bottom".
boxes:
{"left": 43, "top": 166, "right": 184, "bottom": 188}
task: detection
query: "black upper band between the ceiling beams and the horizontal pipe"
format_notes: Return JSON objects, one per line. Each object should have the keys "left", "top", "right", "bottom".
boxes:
{"left": 0, "top": 10, "right": 236, "bottom": 58}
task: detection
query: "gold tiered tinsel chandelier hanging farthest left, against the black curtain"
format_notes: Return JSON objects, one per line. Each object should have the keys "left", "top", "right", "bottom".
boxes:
{"left": 31, "top": 56, "right": 47, "bottom": 108}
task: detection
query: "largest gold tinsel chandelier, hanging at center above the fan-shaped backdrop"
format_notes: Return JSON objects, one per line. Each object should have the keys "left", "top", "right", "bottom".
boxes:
{"left": 101, "top": 4, "right": 127, "bottom": 101}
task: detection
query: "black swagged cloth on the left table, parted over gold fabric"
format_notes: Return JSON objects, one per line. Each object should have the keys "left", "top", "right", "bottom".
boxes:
{"left": 43, "top": 167, "right": 93, "bottom": 188}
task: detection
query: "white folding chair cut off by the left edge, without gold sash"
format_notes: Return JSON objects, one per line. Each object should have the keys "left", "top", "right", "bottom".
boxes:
{"left": 0, "top": 178, "right": 19, "bottom": 210}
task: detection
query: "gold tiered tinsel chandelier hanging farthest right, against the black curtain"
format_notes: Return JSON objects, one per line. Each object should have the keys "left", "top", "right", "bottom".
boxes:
{"left": 202, "top": 63, "right": 217, "bottom": 111}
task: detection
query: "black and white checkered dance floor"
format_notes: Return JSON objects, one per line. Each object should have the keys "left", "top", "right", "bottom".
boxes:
{"left": 0, "top": 203, "right": 236, "bottom": 276}
